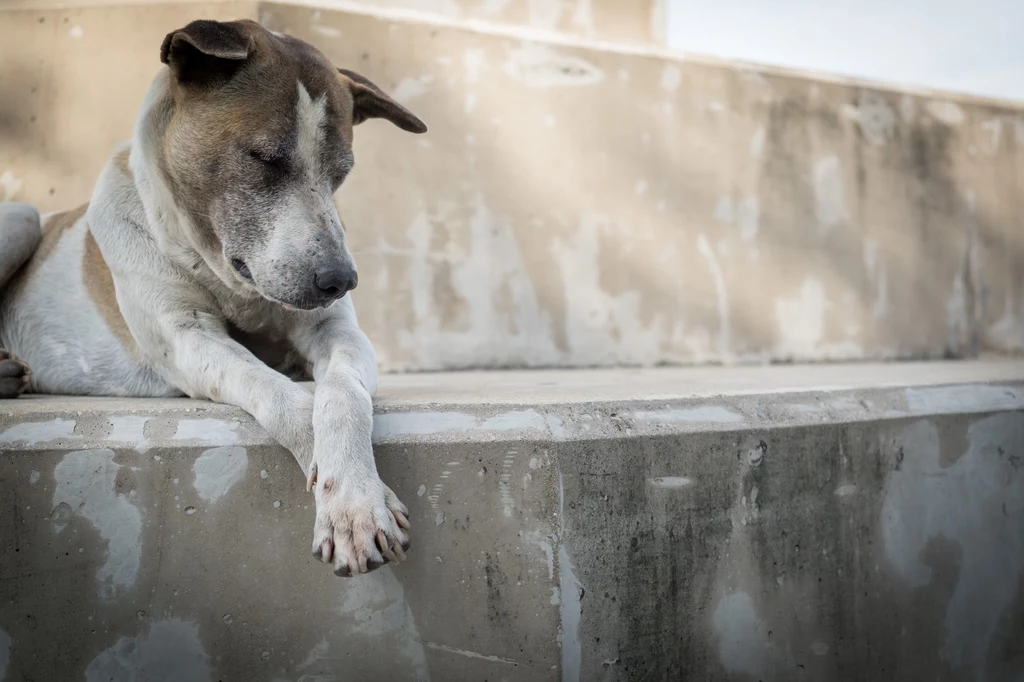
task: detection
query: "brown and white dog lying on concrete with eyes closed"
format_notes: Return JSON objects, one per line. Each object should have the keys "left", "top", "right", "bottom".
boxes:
{"left": 0, "top": 20, "right": 427, "bottom": 577}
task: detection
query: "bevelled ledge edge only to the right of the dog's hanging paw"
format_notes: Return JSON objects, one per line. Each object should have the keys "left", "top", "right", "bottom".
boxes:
{"left": 374, "top": 381, "right": 1024, "bottom": 444}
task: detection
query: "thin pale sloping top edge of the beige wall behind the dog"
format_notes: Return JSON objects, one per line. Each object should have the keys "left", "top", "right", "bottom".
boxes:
{"left": 258, "top": 0, "right": 1024, "bottom": 113}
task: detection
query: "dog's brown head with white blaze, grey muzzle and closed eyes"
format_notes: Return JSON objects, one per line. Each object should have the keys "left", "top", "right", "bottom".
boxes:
{"left": 157, "top": 20, "right": 426, "bottom": 309}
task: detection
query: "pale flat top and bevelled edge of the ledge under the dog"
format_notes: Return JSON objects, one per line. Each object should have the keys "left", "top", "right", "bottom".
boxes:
{"left": 0, "top": 359, "right": 1024, "bottom": 451}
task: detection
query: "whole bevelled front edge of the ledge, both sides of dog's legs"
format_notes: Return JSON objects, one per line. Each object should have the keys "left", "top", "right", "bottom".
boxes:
{"left": 0, "top": 381, "right": 1024, "bottom": 453}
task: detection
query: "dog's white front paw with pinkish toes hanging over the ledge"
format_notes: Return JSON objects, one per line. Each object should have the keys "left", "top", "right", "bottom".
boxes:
{"left": 307, "top": 463, "right": 410, "bottom": 578}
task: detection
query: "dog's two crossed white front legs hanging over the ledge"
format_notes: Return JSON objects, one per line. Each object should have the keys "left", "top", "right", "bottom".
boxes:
{"left": 164, "top": 313, "right": 409, "bottom": 576}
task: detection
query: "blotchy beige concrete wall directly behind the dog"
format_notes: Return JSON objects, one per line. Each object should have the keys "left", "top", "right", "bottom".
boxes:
{"left": 0, "top": 3, "right": 1024, "bottom": 370}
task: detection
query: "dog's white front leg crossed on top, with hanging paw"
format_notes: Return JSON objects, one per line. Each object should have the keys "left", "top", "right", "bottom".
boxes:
{"left": 293, "top": 298, "right": 410, "bottom": 576}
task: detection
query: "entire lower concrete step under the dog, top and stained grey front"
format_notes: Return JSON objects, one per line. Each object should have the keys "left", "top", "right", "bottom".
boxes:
{"left": 0, "top": 360, "right": 1024, "bottom": 682}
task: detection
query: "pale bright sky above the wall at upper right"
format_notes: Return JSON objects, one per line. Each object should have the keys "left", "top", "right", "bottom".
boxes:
{"left": 666, "top": 0, "right": 1024, "bottom": 101}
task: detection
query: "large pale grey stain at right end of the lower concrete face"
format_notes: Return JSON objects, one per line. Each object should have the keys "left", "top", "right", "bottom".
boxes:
{"left": 882, "top": 413, "right": 1024, "bottom": 679}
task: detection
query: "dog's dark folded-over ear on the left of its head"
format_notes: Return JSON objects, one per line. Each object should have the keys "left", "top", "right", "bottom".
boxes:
{"left": 160, "top": 19, "right": 253, "bottom": 84}
